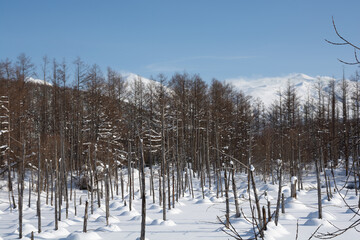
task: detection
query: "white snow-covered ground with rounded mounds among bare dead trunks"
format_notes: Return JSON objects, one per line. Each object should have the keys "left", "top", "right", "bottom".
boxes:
{"left": 0, "top": 165, "right": 359, "bottom": 240}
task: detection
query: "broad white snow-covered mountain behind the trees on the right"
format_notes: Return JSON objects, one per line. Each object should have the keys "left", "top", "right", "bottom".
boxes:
{"left": 226, "top": 73, "right": 351, "bottom": 107}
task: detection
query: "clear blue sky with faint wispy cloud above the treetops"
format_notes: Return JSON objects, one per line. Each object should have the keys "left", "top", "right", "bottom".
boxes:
{"left": 0, "top": 0, "right": 360, "bottom": 82}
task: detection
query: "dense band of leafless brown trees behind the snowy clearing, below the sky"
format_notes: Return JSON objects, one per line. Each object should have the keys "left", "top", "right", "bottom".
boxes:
{"left": 0, "top": 54, "right": 360, "bottom": 189}
